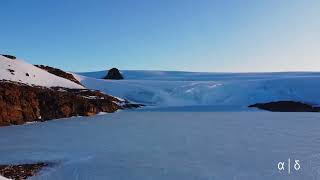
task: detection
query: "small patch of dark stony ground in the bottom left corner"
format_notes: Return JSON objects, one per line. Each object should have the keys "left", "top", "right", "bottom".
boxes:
{"left": 0, "top": 163, "right": 49, "bottom": 180}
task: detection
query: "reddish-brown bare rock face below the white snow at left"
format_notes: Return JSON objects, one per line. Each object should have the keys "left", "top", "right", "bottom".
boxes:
{"left": 0, "top": 81, "right": 139, "bottom": 126}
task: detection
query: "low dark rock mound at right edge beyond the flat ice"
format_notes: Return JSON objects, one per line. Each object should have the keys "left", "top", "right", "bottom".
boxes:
{"left": 249, "top": 101, "right": 320, "bottom": 112}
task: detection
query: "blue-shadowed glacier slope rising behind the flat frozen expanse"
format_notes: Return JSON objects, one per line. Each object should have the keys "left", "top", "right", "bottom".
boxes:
{"left": 76, "top": 71, "right": 320, "bottom": 109}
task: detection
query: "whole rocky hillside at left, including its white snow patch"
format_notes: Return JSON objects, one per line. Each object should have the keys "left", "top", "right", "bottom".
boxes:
{"left": 0, "top": 56, "right": 140, "bottom": 126}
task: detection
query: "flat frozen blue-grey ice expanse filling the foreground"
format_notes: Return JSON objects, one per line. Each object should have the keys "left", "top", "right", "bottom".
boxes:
{"left": 0, "top": 111, "right": 320, "bottom": 180}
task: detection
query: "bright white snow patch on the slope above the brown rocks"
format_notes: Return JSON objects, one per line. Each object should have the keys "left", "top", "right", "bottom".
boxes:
{"left": 0, "top": 55, "right": 84, "bottom": 89}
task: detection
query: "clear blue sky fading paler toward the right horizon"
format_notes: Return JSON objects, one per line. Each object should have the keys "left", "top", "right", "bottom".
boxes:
{"left": 0, "top": 0, "right": 320, "bottom": 71}
